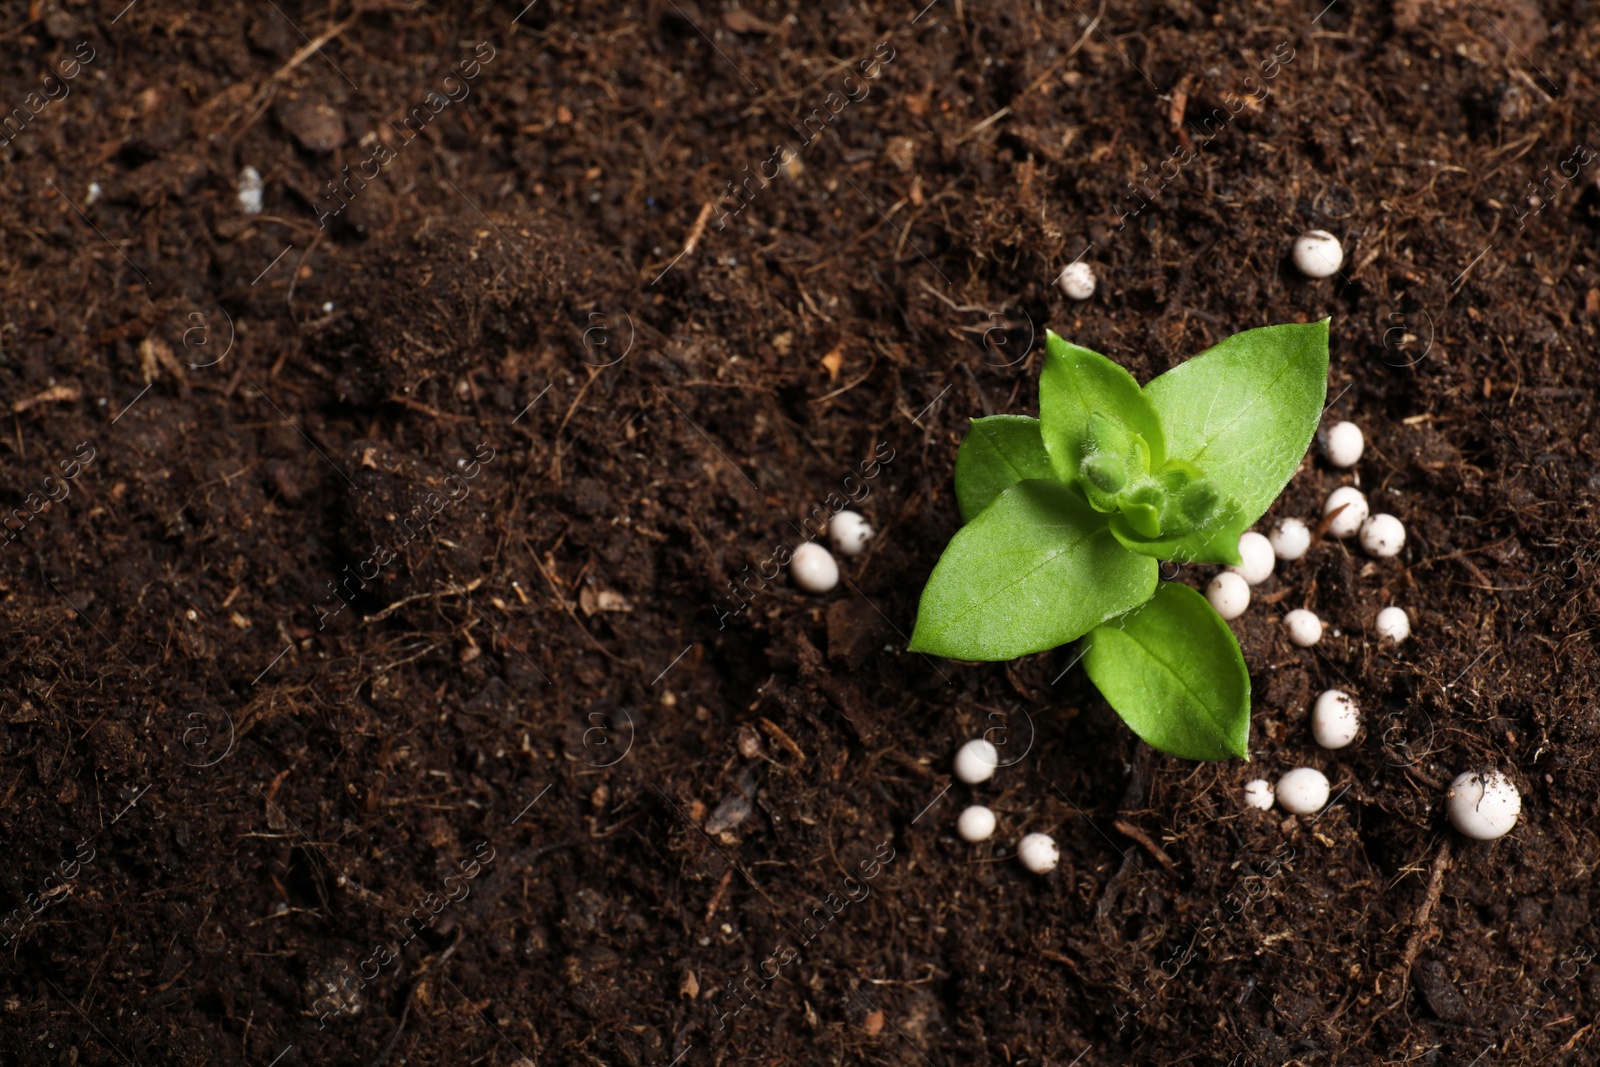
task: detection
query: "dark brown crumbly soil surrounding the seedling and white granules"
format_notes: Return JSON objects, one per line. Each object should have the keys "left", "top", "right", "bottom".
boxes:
{"left": 0, "top": 0, "right": 1600, "bottom": 1067}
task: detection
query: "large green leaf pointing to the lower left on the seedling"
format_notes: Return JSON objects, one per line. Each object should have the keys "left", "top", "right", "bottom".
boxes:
{"left": 910, "top": 480, "right": 1157, "bottom": 661}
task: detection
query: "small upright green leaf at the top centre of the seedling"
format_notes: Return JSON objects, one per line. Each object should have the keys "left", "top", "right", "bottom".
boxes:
{"left": 1038, "top": 330, "right": 1166, "bottom": 483}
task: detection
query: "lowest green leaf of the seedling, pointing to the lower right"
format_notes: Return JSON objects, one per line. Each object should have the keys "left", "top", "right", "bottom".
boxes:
{"left": 1083, "top": 582, "right": 1250, "bottom": 760}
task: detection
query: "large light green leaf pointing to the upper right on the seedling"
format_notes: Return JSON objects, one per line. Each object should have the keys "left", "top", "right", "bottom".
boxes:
{"left": 1145, "top": 318, "right": 1328, "bottom": 530}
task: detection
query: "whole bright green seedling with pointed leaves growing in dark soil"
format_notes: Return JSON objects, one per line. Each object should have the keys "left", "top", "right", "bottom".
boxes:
{"left": 910, "top": 320, "right": 1328, "bottom": 760}
